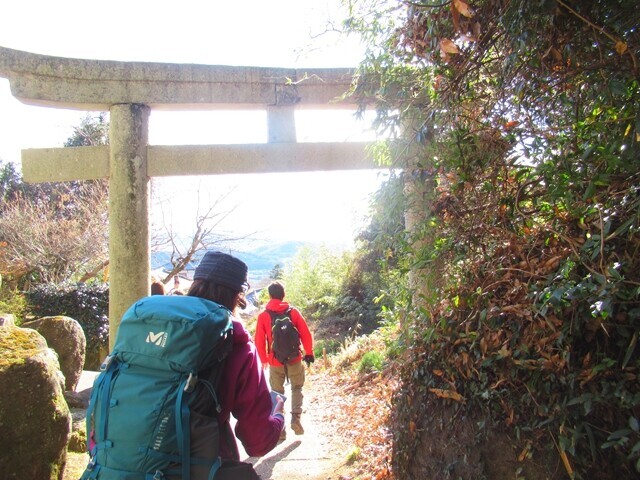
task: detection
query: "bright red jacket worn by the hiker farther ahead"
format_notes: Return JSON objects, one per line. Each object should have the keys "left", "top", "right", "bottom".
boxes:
{"left": 255, "top": 298, "right": 313, "bottom": 367}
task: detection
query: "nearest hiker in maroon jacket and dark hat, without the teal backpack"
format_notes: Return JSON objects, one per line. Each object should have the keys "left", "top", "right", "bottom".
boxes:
{"left": 187, "top": 252, "right": 284, "bottom": 468}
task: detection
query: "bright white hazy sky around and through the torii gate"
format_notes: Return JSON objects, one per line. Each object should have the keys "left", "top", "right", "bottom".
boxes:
{"left": 0, "top": 0, "right": 380, "bottom": 243}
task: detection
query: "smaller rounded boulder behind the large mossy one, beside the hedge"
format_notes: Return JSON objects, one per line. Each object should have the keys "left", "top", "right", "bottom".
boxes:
{"left": 22, "top": 315, "right": 87, "bottom": 390}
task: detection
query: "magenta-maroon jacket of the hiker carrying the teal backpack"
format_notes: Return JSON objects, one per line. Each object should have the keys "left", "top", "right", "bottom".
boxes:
{"left": 218, "top": 320, "right": 284, "bottom": 459}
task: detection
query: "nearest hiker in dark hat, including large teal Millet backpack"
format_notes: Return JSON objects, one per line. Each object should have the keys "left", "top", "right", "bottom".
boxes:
{"left": 82, "top": 252, "right": 284, "bottom": 480}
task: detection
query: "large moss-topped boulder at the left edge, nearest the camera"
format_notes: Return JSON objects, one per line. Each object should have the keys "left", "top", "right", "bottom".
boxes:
{"left": 0, "top": 327, "right": 71, "bottom": 480}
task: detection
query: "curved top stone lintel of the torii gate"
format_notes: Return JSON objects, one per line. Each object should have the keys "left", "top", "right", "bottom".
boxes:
{"left": 0, "top": 47, "right": 355, "bottom": 111}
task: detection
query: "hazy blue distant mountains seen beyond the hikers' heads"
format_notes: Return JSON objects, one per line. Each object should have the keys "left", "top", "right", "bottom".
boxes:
{"left": 151, "top": 241, "right": 311, "bottom": 282}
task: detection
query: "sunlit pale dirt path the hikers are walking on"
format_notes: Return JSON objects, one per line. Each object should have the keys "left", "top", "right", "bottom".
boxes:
{"left": 64, "top": 370, "right": 352, "bottom": 480}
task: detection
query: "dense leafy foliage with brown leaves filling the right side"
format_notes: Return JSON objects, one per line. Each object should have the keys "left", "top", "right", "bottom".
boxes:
{"left": 348, "top": 0, "right": 640, "bottom": 478}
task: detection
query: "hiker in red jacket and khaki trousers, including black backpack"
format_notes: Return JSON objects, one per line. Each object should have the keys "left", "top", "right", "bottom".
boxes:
{"left": 254, "top": 281, "right": 315, "bottom": 440}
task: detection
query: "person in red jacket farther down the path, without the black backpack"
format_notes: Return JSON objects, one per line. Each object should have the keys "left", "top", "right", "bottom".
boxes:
{"left": 255, "top": 281, "right": 314, "bottom": 439}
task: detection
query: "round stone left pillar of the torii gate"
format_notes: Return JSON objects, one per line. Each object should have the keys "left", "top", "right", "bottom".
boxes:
{"left": 109, "top": 104, "right": 151, "bottom": 342}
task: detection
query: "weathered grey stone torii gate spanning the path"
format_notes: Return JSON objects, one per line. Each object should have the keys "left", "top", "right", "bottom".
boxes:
{"left": 0, "top": 47, "right": 376, "bottom": 349}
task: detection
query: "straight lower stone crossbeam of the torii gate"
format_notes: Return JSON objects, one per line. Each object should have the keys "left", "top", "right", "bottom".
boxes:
{"left": 22, "top": 142, "right": 377, "bottom": 183}
